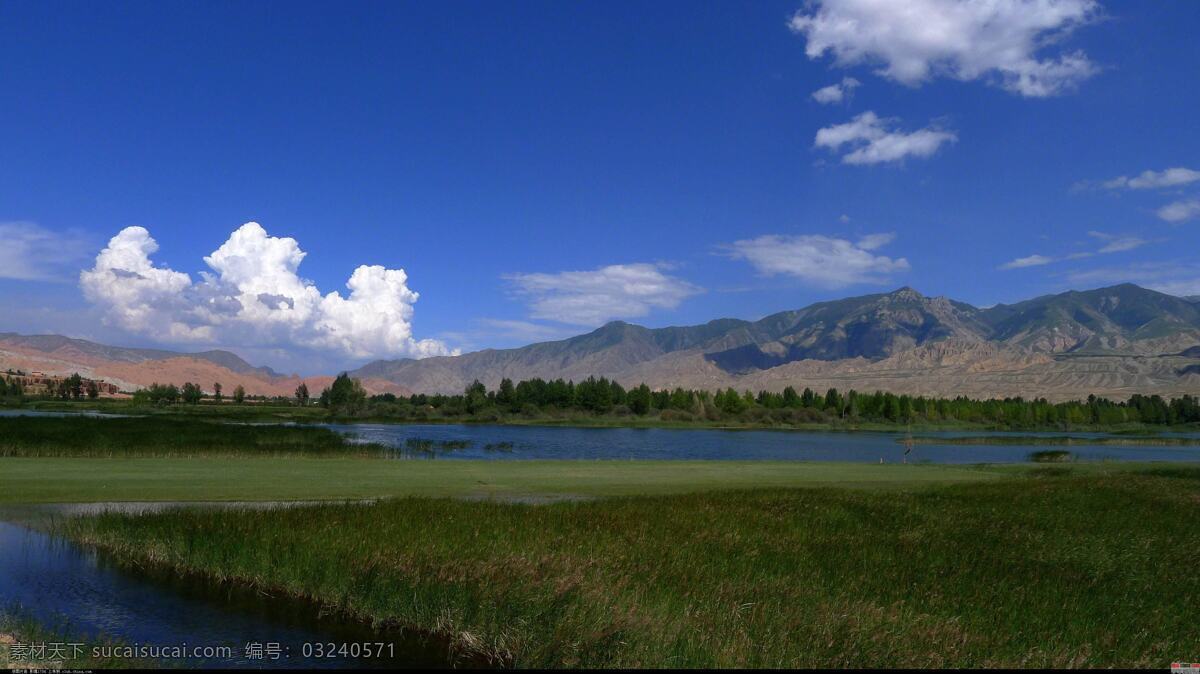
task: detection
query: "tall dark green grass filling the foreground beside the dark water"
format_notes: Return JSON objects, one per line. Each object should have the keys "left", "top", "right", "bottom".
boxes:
{"left": 65, "top": 468, "right": 1200, "bottom": 667}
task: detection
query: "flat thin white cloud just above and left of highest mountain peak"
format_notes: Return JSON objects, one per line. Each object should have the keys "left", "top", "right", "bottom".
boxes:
{"left": 728, "top": 234, "right": 910, "bottom": 288}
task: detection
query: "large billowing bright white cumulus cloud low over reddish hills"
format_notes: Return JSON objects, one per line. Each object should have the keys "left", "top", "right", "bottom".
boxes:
{"left": 79, "top": 222, "right": 452, "bottom": 359}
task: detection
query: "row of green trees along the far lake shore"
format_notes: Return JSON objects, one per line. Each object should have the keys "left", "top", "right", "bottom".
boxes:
{"left": 318, "top": 373, "right": 1200, "bottom": 427}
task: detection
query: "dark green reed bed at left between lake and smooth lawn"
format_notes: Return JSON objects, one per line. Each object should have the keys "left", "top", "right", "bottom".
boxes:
{"left": 0, "top": 416, "right": 384, "bottom": 458}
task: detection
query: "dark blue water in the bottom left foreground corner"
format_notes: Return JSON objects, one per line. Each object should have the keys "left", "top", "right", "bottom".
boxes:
{"left": 0, "top": 504, "right": 450, "bottom": 668}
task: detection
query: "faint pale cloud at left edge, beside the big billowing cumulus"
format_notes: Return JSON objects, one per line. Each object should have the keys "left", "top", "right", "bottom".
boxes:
{"left": 0, "top": 222, "right": 94, "bottom": 283}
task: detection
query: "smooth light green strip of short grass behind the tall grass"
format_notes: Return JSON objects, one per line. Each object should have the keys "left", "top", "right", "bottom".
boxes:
{"left": 0, "top": 457, "right": 1003, "bottom": 503}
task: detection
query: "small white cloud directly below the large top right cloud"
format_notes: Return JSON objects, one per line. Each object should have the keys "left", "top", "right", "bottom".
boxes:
{"left": 814, "top": 110, "right": 958, "bottom": 164}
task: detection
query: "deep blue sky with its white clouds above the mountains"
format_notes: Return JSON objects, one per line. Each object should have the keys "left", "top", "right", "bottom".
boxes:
{"left": 0, "top": 0, "right": 1200, "bottom": 372}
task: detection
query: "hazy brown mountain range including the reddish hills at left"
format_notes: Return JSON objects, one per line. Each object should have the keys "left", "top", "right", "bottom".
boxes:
{"left": 0, "top": 284, "right": 1200, "bottom": 399}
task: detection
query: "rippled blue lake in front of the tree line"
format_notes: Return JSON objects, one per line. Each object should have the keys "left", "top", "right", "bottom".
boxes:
{"left": 328, "top": 423, "right": 1200, "bottom": 463}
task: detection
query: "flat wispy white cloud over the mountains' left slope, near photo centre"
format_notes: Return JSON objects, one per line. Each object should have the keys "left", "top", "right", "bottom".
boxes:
{"left": 505, "top": 263, "right": 702, "bottom": 325}
